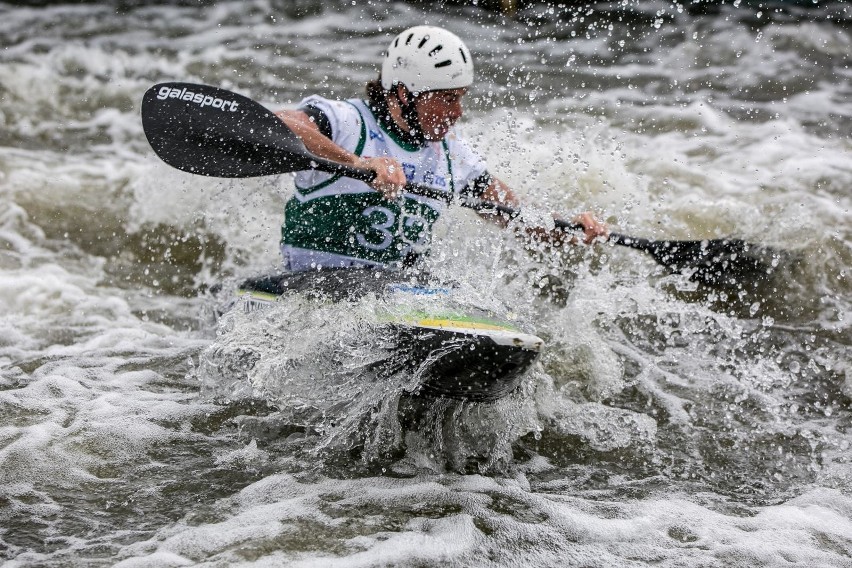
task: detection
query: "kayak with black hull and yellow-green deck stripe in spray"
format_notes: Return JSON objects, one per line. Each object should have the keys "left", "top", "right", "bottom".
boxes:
{"left": 232, "top": 269, "right": 544, "bottom": 402}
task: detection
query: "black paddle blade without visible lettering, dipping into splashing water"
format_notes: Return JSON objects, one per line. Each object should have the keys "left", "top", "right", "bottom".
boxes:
{"left": 619, "top": 237, "right": 778, "bottom": 286}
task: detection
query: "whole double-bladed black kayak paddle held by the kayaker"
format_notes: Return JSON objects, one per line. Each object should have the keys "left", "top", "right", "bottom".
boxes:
{"left": 142, "top": 83, "right": 773, "bottom": 286}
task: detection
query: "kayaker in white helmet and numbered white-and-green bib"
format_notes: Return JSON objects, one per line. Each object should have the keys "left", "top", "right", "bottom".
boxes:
{"left": 277, "top": 26, "right": 607, "bottom": 272}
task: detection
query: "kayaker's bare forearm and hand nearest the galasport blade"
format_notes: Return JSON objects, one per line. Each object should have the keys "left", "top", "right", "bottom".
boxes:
{"left": 275, "top": 110, "right": 405, "bottom": 200}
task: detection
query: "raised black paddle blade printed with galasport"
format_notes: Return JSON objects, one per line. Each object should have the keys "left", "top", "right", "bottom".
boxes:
{"left": 142, "top": 83, "right": 313, "bottom": 178}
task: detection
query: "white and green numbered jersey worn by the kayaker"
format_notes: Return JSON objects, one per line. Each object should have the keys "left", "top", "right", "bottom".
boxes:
{"left": 281, "top": 96, "right": 486, "bottom": 270}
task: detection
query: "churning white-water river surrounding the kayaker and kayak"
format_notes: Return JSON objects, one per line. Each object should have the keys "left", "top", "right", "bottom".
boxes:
{"left": 0, "top": 0, "right": 852, "bottom": 567}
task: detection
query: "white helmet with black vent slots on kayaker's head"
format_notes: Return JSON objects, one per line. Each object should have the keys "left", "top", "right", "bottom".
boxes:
{"left": 382, "top": 26, "right": 473, "bottom": 93}
